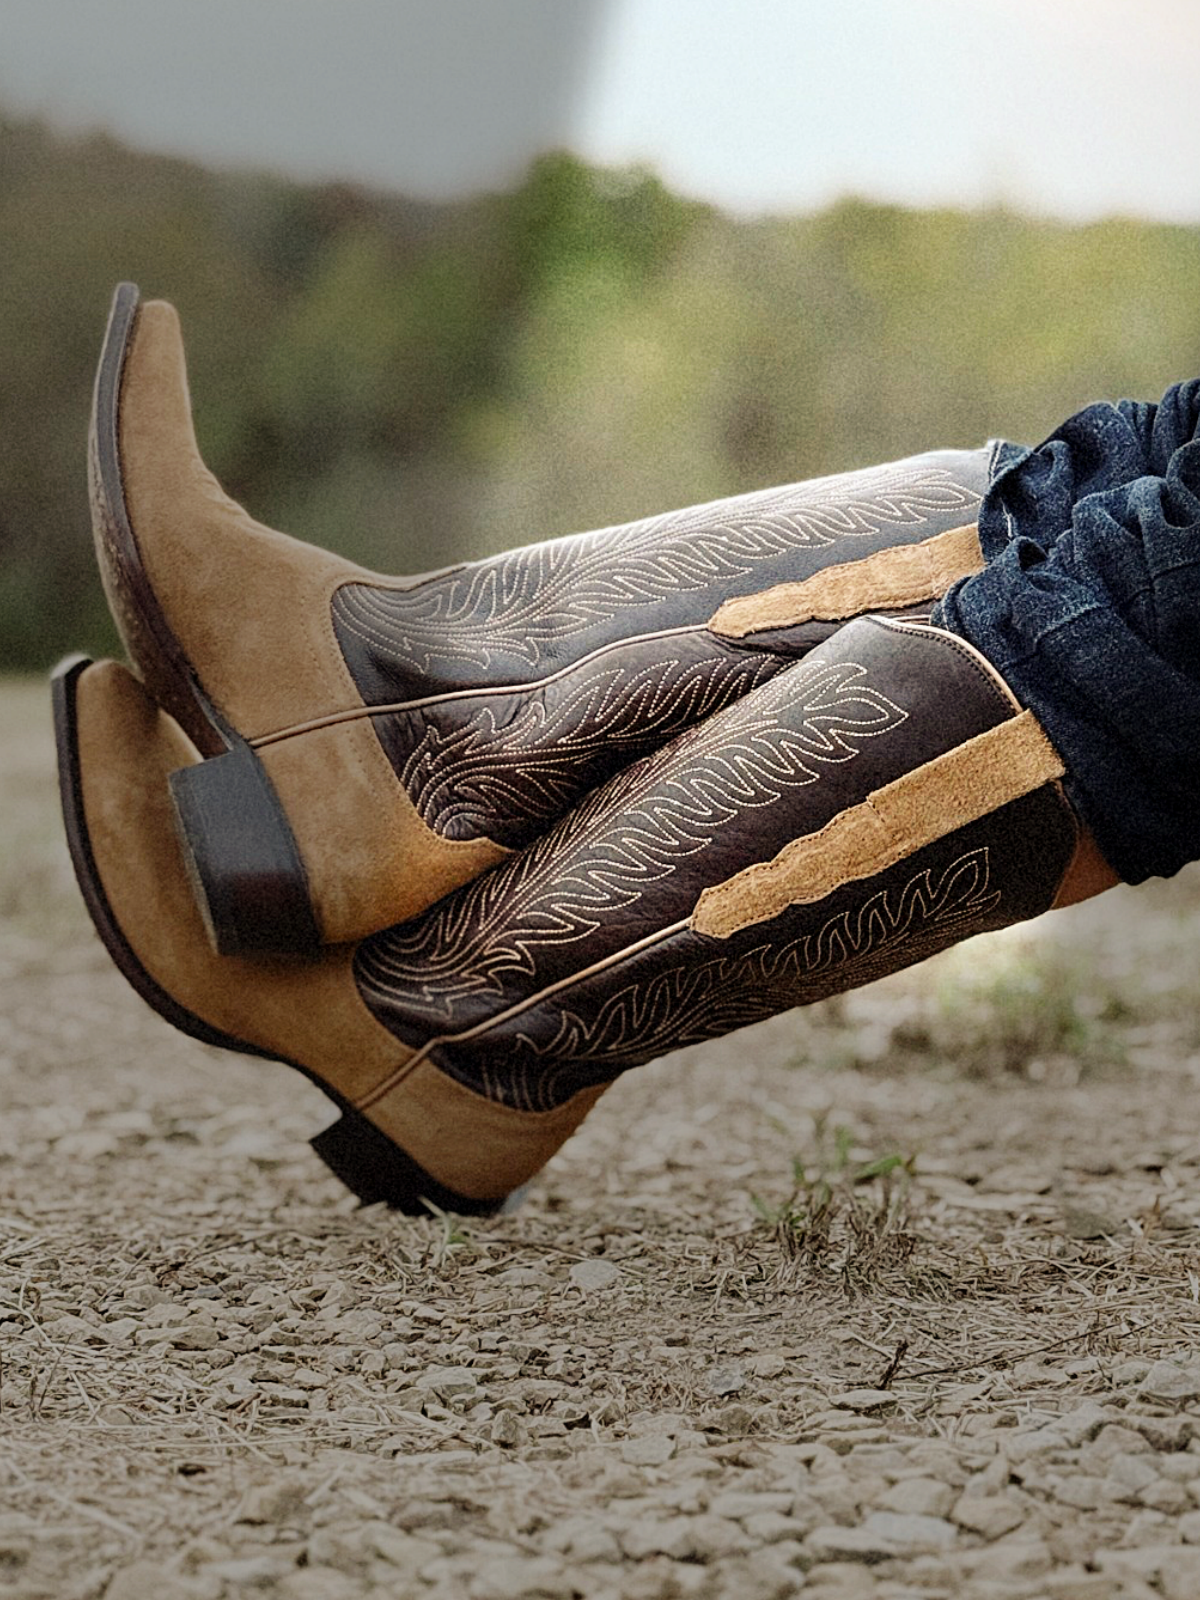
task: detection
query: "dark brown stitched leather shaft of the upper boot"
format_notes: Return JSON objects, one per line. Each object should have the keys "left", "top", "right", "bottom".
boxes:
{"left": 333, "top": 450, "right": 987, "bottom": 846}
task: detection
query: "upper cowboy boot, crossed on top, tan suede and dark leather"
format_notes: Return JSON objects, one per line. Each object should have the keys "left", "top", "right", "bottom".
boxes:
{"left": 90, "top": 285, "right": 990, "bottom": 954}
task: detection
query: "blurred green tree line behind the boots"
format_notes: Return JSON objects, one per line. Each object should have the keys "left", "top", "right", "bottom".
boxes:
{"left": 0, "top": 104, "right": 1200, "bottom": 669}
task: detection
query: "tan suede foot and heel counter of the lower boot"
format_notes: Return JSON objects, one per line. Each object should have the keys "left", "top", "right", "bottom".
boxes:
{"left": 78, "top": 662, "right": 592, "bottom": 1200}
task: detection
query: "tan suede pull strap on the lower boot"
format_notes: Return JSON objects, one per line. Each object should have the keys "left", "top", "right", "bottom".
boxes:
{"left": 691, "top": 710, "right": 1066, "bottom": 939}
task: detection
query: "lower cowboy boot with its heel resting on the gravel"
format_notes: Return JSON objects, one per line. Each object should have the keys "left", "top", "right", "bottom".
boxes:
{"left": 56, "top": 618, "right": 1114, "bottom": 1211}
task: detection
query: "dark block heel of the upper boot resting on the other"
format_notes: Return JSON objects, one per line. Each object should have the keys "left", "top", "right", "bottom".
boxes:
{"left": 168, "top": 741, "right": 322, "bottom": 955}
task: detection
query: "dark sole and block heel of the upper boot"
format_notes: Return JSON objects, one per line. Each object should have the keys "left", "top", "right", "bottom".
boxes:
{"left": 88, "top": 283, "right": 322, "bottom": 955}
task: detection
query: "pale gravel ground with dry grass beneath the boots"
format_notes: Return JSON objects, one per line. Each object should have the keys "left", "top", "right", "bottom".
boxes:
{"left": 0, "top": 685, "right": 1200, "bottom": 1600}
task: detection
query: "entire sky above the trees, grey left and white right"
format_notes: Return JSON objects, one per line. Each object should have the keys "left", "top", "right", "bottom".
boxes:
{"left": 0, "top": 0, "right": 1200, "bottom": 222}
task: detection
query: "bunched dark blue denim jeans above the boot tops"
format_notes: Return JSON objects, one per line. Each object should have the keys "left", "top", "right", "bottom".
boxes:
{"left": 933, "top": 379, "right": 1200, "bottom": 883}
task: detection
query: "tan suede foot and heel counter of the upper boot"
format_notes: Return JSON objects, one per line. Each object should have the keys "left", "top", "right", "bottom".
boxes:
{"left": 120, "top": 301, "right": 507, "bottom": 944}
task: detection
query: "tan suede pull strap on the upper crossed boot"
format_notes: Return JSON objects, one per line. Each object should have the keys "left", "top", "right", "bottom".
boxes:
{"left": 709, "top": 523, "right": 984, "bottom": 638}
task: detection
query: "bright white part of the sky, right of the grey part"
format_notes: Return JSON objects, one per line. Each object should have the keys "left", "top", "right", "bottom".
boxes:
{"left": 582, "top": 0, "right": 1200, "bottom": 221}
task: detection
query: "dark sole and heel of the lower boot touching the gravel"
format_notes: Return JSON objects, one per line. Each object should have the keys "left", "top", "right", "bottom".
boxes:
{"left": 51, "top": 656, "right": 512, "bottom": 1216}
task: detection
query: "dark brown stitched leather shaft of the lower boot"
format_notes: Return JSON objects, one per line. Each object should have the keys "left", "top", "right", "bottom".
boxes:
{"left": 355, "top": 619, "right": 1077, "bottom": 1110}
